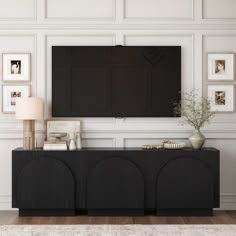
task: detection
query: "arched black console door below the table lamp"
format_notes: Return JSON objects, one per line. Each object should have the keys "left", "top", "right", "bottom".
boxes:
{"left": 17, "top": 156, "right": 75, "bottom": 209}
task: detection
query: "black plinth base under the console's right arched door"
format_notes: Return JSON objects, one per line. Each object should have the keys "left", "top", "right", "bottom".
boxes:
{"left": 156, "top": 209, "right": 213, "bottom": 216}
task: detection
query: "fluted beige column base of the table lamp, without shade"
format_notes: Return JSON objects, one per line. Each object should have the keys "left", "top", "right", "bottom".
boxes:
{"left": 23, "top": 120, "right": 35, "bottom": 150}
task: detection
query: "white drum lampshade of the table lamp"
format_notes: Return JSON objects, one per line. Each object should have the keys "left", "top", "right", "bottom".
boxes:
{"left": 16, "top": 97, "right": 43, "bottom": 120}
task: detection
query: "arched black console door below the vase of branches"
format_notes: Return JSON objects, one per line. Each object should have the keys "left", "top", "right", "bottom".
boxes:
{"left": 156, "top": 156, "right": 214, "bottom": 209}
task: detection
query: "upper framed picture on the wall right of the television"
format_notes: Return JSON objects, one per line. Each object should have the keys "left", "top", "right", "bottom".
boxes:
{"left": 208, "top": 53, "right": 234, "bottom": 81}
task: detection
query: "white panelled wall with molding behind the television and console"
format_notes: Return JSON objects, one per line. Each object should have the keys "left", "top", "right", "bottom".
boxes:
{"left": 0, "top": 0, "right": 236, "bottom": 209}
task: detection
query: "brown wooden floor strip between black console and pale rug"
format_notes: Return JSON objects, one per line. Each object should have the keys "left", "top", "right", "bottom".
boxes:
{"left": 0, "top": 211, "right": 236, "bottom": 224}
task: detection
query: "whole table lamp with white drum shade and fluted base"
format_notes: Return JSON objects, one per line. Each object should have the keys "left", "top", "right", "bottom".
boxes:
{"left": 16, "top": 97, "right": 43, "bottom": 150}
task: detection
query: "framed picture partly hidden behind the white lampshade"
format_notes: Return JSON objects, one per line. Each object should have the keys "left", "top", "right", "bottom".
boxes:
{"left": 2, "top": 85, "right": 30, "bottom": 113}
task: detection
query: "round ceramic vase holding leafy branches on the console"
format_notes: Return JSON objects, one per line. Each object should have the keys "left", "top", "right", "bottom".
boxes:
{"left": 174, "top": 90, "right": 214, "bottom": 149}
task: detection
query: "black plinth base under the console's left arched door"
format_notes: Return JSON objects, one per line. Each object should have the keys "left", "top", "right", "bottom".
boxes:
{"left": 19, "top": 209, "right": 76, "bottom": 216}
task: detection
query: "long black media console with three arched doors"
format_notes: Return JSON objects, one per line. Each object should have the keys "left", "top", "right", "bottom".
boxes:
{"left": 12, "top": 148, "right": 220, "bottom": 216}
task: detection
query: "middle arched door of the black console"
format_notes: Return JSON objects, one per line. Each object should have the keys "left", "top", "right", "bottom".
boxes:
{"left": 87, "top": 157, "right": 144, "bottom": 214}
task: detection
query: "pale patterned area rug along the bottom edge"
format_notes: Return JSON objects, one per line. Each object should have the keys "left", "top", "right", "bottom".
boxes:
{"left": 0, "top": 225, "right": 236, "bottom": 236}
